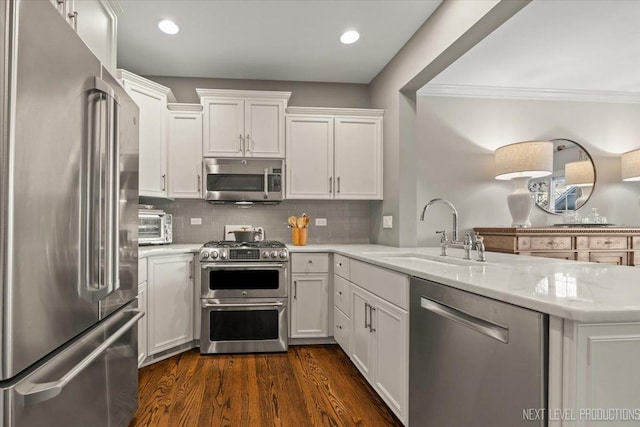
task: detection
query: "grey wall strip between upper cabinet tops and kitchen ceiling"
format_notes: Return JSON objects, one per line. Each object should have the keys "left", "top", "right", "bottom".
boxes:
{"left": 145, "top": 76, "right": 369, "bottom": 108}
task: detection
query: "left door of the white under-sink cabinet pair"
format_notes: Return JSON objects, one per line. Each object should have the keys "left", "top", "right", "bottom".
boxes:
{"left": 349, "top": 285, "right": 373, "bottom": 381}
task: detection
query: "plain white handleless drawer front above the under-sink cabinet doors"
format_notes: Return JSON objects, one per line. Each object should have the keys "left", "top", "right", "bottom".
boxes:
{"left": 349, "top": 259, "right": 409, "bottom": 310}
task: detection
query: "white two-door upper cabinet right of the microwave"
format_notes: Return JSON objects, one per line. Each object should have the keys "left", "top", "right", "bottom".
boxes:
{"left": 286, "top": 107, "right": 383, "bottom": 200}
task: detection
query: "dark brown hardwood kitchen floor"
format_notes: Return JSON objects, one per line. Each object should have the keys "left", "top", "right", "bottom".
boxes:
{"left": 129, "top": 345, "right": 402, "bottom": 427}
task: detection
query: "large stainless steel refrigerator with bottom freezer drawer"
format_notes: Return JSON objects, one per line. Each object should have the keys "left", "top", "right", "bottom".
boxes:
{"left": 0, "top": 0, "right": 142, "bottom": 427}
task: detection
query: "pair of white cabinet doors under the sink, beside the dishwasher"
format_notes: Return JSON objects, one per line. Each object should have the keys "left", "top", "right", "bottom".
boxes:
{"left": 348, "top": 267, "right": 409, "bottom": 423}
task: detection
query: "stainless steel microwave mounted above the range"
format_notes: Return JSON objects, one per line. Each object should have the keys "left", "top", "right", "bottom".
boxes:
{"left": 203, "top": 159, "right": 284, "bottom": 204}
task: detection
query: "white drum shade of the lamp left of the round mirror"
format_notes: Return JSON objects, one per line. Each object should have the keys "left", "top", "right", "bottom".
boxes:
{"left": 495, "top": 141, "right": 553, "bottom": 180}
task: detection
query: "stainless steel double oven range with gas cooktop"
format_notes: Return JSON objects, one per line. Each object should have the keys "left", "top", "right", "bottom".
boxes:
{"left": 200, "top": 241, "right": 289, "bottom": 354}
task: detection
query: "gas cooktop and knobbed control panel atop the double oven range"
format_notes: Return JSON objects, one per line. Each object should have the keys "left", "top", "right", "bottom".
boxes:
{"left": 200, "top": 240, "right": 289, "bottom": 262}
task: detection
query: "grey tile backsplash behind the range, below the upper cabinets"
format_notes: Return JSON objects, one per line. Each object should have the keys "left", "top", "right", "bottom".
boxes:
{"left": 155, "top": 199, "right": 370, "bottom": 244}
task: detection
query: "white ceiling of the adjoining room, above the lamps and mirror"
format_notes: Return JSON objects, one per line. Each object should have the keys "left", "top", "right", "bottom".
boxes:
{"left": 428, "top": 0, "right": 640, "bottom": 92}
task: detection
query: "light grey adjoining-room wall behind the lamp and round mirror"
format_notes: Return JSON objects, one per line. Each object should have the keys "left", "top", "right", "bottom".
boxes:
{"left": 416, "top": 96, "right": 640, "bottom": 246}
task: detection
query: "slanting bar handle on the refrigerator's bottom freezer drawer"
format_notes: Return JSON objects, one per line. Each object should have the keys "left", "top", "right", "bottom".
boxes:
{"left": 15, "top": 309, "right": 144, "bottom": 406}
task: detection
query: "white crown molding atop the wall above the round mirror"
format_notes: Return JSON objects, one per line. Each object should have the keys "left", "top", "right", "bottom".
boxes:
{"left": 418, "top": 84, "right": 640, "bottom": 104}
